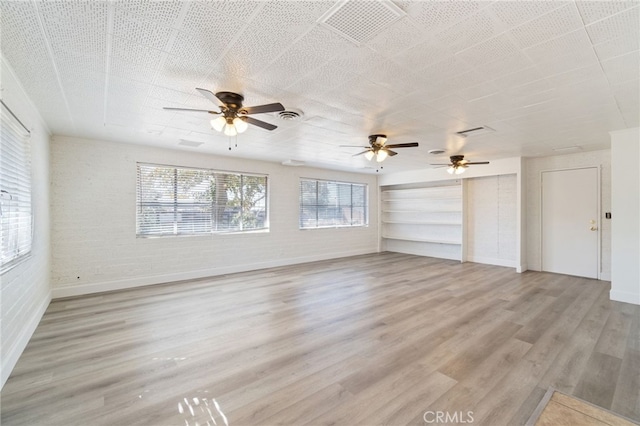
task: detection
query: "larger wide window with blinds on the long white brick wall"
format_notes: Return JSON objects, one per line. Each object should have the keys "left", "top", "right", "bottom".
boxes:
{"left": 136, "top": 164, "right": 269, "bottom": 236}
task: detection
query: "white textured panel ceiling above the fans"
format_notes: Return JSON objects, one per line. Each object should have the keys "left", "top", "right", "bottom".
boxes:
{"left": 0, "top": 0, "right": 640, "bottom": 173}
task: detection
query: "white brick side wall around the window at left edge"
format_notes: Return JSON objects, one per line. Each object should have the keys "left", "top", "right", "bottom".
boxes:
{"left": 0, "top": 59, "right": 51, "bottom": 387}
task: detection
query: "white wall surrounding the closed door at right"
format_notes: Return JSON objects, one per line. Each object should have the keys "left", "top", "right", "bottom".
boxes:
{"left": 526, "top": 149, "right": 611, "bottom": 280}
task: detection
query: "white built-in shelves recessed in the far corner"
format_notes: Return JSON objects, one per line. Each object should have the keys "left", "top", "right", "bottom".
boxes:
{"left": 381, "top": 180, "right": 464, "bottom": 261}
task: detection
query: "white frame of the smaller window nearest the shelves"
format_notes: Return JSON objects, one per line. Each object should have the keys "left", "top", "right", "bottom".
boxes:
{"left": 298, "top": 177, "right": 369, "bottom": 231}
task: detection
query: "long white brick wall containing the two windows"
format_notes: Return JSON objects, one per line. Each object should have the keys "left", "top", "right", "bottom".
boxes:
{"left": 51, "top": 136, "right": 378, "bottom": 297}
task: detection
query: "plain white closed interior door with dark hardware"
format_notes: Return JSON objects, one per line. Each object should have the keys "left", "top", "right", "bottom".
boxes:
{"left": 542, "top": 167, "right": 600, "bottom": 278}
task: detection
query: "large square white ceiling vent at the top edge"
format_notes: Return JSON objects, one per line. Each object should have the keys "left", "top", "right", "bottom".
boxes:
{"left": 318, "top": 0, "right": 405, "bottom": 46}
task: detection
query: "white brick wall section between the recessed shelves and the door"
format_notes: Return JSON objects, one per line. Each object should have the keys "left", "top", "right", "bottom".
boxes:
{"left": 465, "top": 174, "right": 518, "bottom": 267}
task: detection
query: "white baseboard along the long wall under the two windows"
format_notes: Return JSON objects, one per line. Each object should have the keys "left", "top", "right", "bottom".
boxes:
{"left": 52, "top": 250, "right": 376, "bottom": 299}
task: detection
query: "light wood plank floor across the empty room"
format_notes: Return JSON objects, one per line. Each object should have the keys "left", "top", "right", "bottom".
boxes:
{"left": 1, "top": 253, "right": 640, "bottom": 426}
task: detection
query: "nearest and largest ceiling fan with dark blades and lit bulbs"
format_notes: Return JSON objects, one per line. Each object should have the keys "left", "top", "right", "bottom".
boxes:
{"left": 163, "top": 88, "right": 284, "bottom": 149}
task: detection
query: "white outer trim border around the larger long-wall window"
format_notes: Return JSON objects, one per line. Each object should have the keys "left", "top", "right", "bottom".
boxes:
{"left": 135, "top": 161, "right": 271, "bottom": 239}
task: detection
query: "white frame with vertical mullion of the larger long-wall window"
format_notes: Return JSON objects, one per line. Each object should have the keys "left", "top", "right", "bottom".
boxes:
{"left": 135, "top": 161, "right": 270, "bottom": 239}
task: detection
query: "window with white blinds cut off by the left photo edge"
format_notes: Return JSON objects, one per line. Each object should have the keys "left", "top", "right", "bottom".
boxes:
{"left": 0, "top": 102, "right": 33, "bottom": 273}
